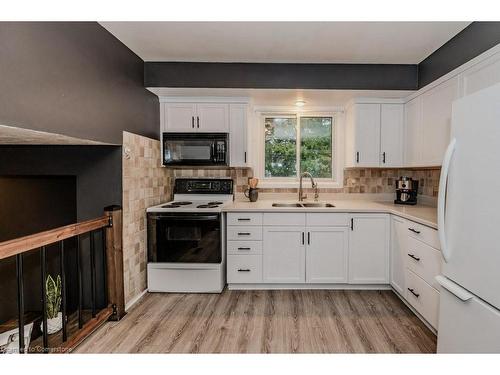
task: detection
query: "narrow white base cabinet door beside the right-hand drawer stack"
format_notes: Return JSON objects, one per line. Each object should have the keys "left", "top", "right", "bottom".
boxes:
{"left": 390, "top": 216, "right": 408, "bottom": 296}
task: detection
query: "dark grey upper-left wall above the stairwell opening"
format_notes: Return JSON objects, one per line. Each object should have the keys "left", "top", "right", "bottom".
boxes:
{"left": 0, "top": 22, "right": 159, "bottom": 144}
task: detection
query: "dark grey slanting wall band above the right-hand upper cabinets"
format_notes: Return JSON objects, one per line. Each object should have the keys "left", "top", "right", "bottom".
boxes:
{"left": 418, "top": 22, "right": 500, "bottom": 88}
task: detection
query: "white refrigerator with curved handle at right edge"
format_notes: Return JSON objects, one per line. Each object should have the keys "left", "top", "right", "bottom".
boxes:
{"left": 437, "top": 84, "right": 500, "bottom": 353}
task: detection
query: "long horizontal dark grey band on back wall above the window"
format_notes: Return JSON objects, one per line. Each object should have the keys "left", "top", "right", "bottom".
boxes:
{"left": 144, "top": 62, "right": 418, "bottom": 90}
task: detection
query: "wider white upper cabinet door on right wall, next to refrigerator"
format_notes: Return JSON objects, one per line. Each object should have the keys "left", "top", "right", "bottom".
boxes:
{"left": 421, "top": 77, "right": 458, "bottom": 166}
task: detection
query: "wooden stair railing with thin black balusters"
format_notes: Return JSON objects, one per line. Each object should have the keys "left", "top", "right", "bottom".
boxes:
{"left": 0, "top": 206, "right": 125, "bottom": 353}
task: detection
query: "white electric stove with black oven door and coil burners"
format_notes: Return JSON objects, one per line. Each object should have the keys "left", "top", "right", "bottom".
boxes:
{"left": 146, "top": 178, "right": 233, "bottom": 293}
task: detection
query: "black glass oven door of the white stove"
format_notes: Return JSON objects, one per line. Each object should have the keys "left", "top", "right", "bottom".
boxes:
{"left": 148, "top": 213, "right": 222, "bottom": 263}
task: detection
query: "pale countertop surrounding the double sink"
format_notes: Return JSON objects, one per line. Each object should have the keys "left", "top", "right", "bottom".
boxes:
{"left": 223, "top": 199, "right": 437, "bottom": 229}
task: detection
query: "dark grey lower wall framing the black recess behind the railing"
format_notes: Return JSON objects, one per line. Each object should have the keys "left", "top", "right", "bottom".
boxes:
{"left": 0, "top": 146, "right": 122, "bottom": 221}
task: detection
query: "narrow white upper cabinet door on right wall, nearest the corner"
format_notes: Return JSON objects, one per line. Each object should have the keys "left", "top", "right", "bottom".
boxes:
{"left": 404, "top": 97, "right": 422, "bottom": 166}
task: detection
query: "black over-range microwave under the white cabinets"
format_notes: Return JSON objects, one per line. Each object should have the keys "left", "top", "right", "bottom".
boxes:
{"left": 162, "top": 133, "right": 229, "bottom": 166}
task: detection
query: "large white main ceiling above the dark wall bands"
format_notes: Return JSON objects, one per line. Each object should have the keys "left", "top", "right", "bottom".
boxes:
{"left": 101, "top": 22, "right": 470, "bottom": 64}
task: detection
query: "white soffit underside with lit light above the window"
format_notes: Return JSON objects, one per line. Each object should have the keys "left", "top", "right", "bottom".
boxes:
{"left": 148, "top": 87, "right": 414, "bottom": 109}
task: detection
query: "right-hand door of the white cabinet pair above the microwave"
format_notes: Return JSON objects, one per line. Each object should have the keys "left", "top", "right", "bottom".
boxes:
{"left": 196, "top": 103, "right": 229, "bottom": 133}
